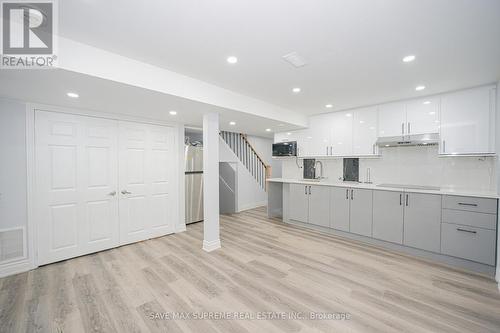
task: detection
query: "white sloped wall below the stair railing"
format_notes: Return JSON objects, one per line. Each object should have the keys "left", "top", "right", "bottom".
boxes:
{"left": 219, "top": 138, "right": 267, "bottom": 212}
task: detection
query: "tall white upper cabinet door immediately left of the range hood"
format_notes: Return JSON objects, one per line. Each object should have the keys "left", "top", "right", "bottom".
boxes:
{"left": 352, "top": 107, "right": 378, "bottom": 156}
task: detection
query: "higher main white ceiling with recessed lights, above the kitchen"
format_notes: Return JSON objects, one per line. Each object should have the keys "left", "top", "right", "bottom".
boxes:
{"left": 59, "top": 0, "right": 500, "bottom": 114}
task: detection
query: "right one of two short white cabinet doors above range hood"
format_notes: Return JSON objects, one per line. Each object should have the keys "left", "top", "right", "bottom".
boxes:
{"left": 405, "top": 97, "right": 440, "bottom": 135}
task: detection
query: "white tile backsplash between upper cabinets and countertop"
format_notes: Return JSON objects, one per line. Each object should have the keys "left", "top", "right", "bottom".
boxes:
{"left": 282, "top": 146, "right": 497, "bottom": 191}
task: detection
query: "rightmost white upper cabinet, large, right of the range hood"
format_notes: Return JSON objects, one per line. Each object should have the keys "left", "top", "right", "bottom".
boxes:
{"left": 439, "top": 86, "right": 496, "bottom": 154}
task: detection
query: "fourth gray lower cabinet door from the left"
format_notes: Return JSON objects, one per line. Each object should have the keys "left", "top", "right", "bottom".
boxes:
{"left": 350, "top": 189, "right": 373, "bottom": 237}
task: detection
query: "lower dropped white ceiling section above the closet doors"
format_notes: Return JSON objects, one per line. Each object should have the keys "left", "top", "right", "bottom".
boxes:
{"left": 0, "top": 69, "right": 297, "bottom": 137}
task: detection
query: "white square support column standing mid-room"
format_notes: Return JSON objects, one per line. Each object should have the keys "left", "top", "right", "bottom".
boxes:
{"left": 203, "top": 113, "right": 220, "bottom": 252}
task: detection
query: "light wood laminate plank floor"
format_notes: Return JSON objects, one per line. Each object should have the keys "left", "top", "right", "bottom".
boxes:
{"left": 0, "top": 208, "right": 500, "bottom": 333}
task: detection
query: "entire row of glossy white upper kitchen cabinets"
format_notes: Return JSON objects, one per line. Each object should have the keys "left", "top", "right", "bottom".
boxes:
{"left": 274, "top": 86, "right": 496, "bottom": 157}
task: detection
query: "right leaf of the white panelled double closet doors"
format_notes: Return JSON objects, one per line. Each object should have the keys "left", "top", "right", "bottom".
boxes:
{"left": 119, "top": 122, "right": 177, "bottom": 244}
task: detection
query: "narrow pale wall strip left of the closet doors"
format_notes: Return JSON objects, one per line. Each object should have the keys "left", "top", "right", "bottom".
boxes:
{"left": 0, "top": 100, "right": 27, "bottom": 264}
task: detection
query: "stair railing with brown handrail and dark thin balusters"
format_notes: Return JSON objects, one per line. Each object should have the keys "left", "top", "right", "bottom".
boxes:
{"left": 220, "top": 131, "right": 271, "bottom": 191}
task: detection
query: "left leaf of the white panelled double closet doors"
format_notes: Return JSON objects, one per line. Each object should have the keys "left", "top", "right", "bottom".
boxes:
{"left": 35, "top": 111, "right": 119, "bottom": 264}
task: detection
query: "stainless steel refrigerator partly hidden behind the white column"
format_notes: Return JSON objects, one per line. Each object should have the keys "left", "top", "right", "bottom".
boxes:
{"left": 184, "top": 144, "right": 203, "bottom": 224}
